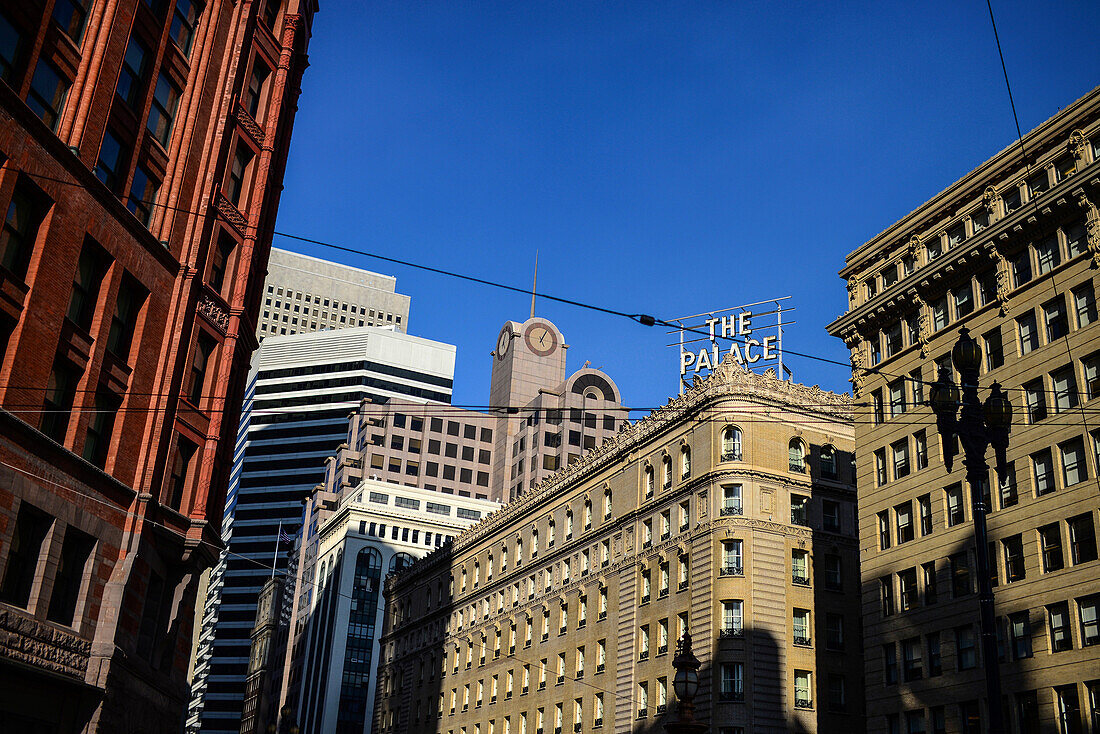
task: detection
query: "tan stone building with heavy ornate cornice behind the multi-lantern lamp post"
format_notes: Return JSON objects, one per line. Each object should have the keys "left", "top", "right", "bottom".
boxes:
{"left": 828, "top": 88, "right": 1100, "bottom": 734}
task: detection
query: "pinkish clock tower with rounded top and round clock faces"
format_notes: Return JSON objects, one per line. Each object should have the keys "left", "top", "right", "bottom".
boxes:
{"left": 487, "top": 317, "right": 569, "bottom": 497}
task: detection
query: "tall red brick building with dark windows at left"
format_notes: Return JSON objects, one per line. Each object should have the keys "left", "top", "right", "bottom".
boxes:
{"left": 0, "top": 0, "right": 316, "bottom": 734}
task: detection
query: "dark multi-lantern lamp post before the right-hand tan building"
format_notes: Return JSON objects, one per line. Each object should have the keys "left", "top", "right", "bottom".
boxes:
{"left": 930, "top": 327, "right": 1012, "bottom": 734}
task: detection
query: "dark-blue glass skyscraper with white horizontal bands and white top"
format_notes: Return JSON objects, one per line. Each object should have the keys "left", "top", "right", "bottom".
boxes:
{"left": 187, "top": 327, "right": 455, "bottom": 734}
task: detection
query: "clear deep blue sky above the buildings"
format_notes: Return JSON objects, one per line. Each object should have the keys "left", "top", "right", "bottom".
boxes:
{"left": 275, "top": 0, "right": 1100, "bottom": 417}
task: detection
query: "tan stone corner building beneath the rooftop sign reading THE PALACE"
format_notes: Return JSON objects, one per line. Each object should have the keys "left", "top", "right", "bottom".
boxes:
{"left": 374, "top": 362, "right": 862, "bottom": 734}
